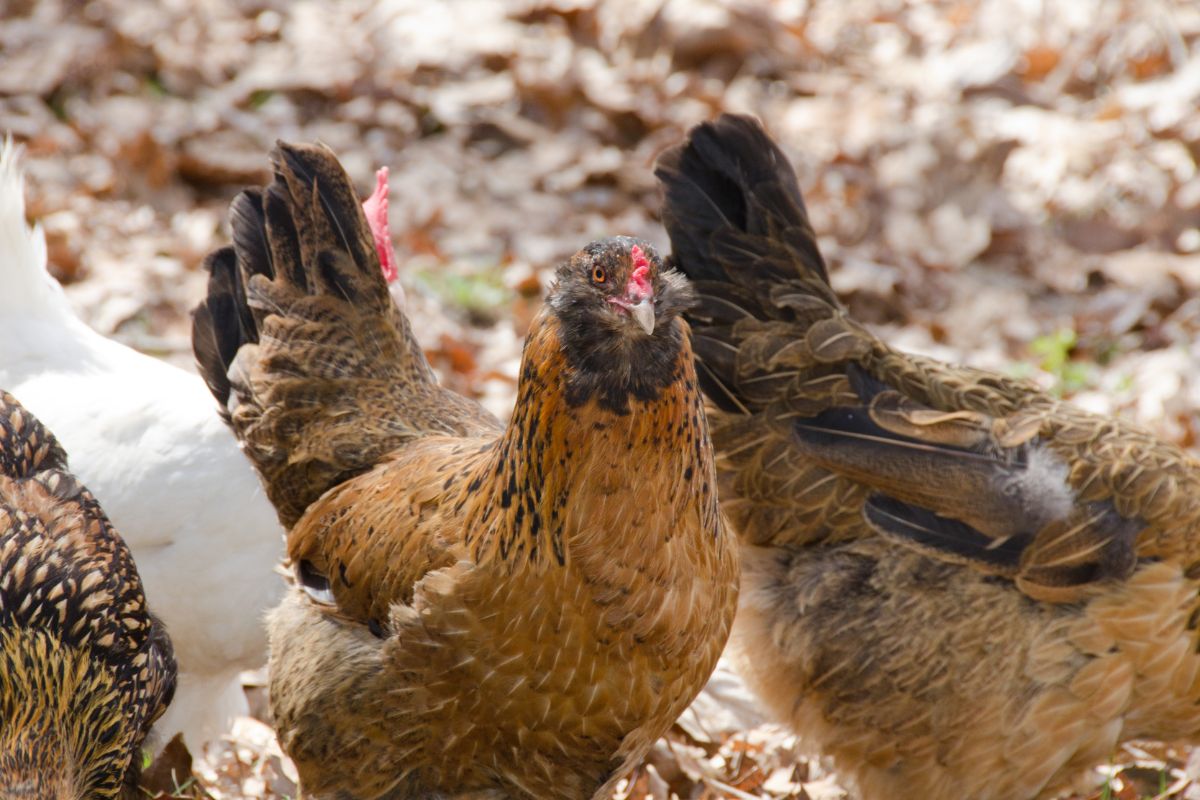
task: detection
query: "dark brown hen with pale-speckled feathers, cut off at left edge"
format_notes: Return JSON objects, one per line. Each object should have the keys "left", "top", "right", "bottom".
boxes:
{"left": 0, "top": 391, "right": 175, "bottom": 800}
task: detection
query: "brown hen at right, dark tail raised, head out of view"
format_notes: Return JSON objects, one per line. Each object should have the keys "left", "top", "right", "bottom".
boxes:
{"left": 658, "top": 116, "right": 1200, "bottom": 800}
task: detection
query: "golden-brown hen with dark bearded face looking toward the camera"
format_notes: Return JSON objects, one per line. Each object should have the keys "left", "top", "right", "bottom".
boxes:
{"left": 193, "top": 144, "right": 738, "bottom": 799}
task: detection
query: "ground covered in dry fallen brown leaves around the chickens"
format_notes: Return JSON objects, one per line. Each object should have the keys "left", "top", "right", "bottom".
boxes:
{"left": 0, "top": 0, "right": 1200, "bottom": 800}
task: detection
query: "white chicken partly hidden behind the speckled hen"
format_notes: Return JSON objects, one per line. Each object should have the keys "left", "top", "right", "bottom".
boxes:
{"left": 0, "top": 144, "right": 283, "bottom": 748}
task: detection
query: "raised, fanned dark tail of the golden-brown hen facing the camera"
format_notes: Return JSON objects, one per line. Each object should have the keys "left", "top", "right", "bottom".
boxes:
{"left": 192, "top": 142, "right": 487, "bottom": 527}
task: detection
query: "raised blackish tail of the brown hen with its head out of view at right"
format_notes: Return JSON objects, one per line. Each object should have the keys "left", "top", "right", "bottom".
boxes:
{"left": 655, "top": 114, "right": 858, "bottom": 414}
